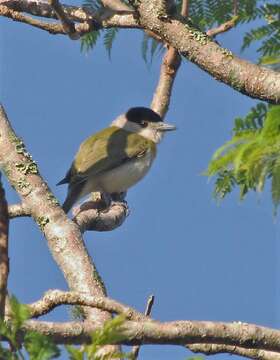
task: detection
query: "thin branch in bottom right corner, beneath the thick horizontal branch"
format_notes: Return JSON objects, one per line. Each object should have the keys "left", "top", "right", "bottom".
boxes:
{"left": 186, "top": 344, "right": 280, "bottom": 360}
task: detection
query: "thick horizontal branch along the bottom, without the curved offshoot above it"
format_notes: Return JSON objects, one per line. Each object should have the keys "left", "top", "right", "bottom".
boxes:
{"left": 20, "top": 319, "right": 280, "bottom": 353}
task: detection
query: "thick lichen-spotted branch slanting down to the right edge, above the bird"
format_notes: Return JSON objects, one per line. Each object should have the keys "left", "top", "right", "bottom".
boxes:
{"left": 138, "top": 0, "right": 280, "bottom": 104}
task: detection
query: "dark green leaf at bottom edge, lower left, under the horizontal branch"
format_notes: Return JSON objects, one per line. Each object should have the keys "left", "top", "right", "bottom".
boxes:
{"left": 24, "top": 332, "right": 60, "bottom": 360}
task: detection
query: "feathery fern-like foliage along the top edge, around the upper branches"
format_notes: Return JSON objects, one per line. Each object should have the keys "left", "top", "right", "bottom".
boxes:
{"left": 81, "top": 0, "right": 280, "bottom": 70}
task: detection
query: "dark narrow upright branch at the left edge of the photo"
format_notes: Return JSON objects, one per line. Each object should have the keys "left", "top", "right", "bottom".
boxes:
{"left": 0, "top": 173, "right": 9, "bottom": 318}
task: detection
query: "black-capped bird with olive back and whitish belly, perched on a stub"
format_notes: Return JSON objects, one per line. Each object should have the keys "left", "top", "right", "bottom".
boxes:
{"left": 57, "top": 106, "right": 176, "bottom": 213}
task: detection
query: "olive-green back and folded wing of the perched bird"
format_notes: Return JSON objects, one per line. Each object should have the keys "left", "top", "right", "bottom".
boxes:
{"left": 68, "top": 126, "right": 156, "bottom": 184}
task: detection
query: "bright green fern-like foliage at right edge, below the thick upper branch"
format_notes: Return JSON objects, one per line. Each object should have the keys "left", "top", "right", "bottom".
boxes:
{"left": 206, "top": 103, "right": 280, "bottom": 211}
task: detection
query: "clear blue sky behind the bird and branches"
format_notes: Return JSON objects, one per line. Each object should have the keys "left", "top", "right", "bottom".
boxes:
{"left": 0, "top": 7, "right": 279, "bottom": 360}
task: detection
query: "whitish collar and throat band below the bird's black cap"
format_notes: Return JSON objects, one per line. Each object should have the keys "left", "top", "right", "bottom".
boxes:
{"left": 111, "top": 115, "right": 163, "bottom": 144}
